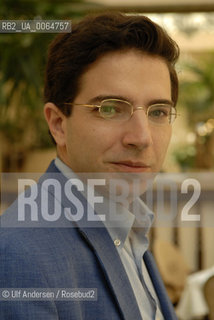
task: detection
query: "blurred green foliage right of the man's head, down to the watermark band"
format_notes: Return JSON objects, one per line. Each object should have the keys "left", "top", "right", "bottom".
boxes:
{"left": 173, "top": 52, "right": 214, "bottom": 170}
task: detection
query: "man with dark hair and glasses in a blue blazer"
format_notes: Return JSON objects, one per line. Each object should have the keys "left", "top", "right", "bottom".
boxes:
{"left": 0, "top": 13, "right": 179, "bottom": 320}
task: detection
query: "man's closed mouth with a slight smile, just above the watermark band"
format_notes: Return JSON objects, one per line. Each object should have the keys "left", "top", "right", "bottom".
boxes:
{"left": 109, "top": 161, "right": 151, "bottom": 172}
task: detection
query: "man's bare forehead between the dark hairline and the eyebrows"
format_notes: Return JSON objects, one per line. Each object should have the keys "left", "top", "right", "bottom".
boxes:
{"left": 75, "top": 50, "right": 171, "bottom": 102}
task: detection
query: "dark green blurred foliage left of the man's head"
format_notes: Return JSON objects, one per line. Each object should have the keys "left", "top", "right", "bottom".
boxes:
{"left": 0, "top": 0, "right": 84, "bottom": 150}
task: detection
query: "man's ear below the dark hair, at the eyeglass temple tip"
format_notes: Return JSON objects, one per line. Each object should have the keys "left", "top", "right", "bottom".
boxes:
{"left": 44, "top": 102, "right": 66, "bottom": 147}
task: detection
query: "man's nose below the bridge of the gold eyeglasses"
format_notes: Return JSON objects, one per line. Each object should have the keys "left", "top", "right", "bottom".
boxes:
{"left": 123, "top": 108, "right": 152, "bottom": 150}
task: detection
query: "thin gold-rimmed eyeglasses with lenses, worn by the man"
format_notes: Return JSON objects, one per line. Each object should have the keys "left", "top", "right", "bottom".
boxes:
{"left": 65, "top": 99, "right": 177, "bottom": 125}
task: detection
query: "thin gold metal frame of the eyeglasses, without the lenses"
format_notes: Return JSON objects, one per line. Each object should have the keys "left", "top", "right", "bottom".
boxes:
{"left": 64, "top": 98, "right": 179, "bottom": 125}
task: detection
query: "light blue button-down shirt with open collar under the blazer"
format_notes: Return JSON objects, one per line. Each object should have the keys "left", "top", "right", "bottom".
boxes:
{"left": 55, "top": 158, "right": 163, "bottom": 320}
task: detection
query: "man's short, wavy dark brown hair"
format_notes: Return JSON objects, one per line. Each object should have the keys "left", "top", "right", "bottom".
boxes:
{"left": 44, "top": 13, "right": 179, "bottom": 116}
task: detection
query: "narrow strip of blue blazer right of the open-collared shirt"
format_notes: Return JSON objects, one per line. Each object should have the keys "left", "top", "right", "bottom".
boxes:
{"left": 143, "top": 251, "right": 177, "bottom": 320}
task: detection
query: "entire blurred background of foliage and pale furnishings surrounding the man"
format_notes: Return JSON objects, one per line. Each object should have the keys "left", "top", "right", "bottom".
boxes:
{"left": 0, "top": 0, "right": 214, "bottom": 320}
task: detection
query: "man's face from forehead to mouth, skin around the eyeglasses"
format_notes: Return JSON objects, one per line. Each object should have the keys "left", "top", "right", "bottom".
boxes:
{"left": 55, "top": 50, "right": 171, "bottom": 173}
